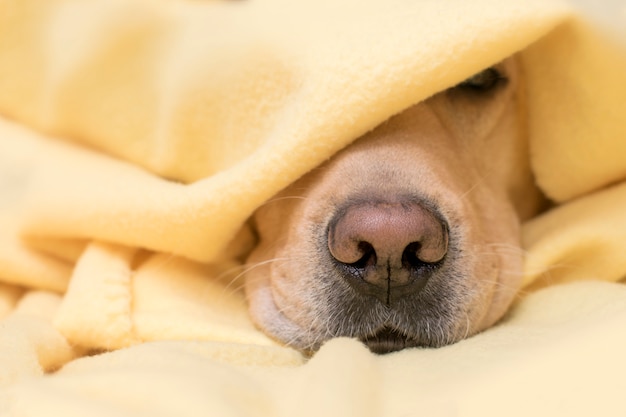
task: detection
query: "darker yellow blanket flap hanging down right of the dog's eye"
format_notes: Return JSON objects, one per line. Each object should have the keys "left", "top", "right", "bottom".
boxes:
{"left": 523, "top": 20, "right": 626, "bottom": 203}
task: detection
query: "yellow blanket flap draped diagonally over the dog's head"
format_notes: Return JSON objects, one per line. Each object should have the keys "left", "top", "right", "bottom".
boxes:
{"left": 0, "top": 0, "right": 565, "bottom": 261}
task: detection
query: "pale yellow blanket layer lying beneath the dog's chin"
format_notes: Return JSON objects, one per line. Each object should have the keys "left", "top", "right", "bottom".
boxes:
{"left": 10, "top": 282, "right": 626, "bottom": 417}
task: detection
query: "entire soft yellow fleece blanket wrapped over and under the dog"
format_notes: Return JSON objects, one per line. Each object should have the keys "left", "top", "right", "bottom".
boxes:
{"left": 0, "top": 0, "right": 626, "bottom": 416}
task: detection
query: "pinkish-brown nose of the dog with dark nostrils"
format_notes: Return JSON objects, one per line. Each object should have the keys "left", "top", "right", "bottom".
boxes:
{"left": 328, "top": 201, "right": 448, "bottom": 305}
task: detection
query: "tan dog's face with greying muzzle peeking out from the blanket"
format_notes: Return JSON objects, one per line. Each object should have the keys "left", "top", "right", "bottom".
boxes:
{"left": 246, "top": 58, "right": 541, "bottom": 352}
